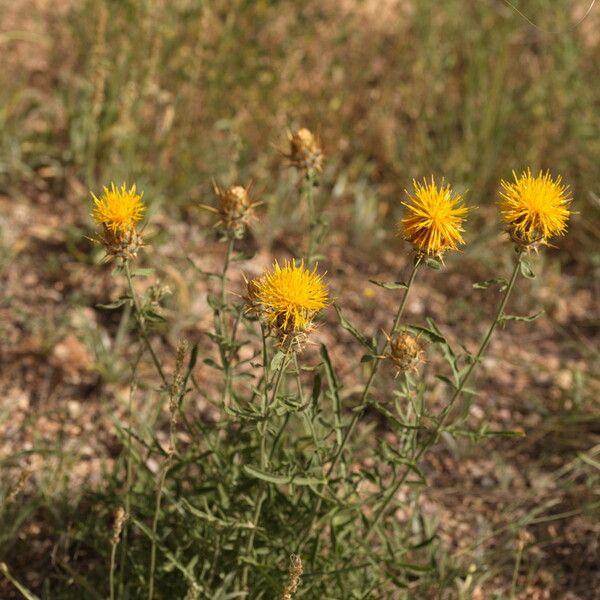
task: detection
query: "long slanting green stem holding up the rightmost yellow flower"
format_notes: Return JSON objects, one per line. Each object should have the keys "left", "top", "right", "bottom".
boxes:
{"left": 367, "top": 251, "right": 522, "bottom": 535}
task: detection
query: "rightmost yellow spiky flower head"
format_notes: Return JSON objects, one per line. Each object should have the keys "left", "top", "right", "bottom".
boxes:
{"left": 499, "top": 169, "right": 571, "bottom": 246}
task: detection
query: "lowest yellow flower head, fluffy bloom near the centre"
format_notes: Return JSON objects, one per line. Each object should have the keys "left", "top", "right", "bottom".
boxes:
{"left": 254, "top": 261, "right": 329, "bottom": 334}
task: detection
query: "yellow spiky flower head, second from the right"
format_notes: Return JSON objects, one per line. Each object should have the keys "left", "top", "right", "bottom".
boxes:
{"left": 401, "top": 177, "right": 469, "bottom": 256}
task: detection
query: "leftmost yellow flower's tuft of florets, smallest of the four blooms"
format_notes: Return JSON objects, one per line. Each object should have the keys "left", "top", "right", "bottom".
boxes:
{"left": 92, "top": 183, "right": 146, "bottom": 235}
